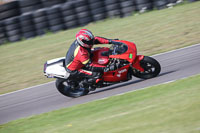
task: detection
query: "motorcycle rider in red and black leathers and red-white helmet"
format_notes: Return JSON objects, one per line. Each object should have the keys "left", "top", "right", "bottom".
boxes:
{"left": 65, "top": 29, "right": 117, "bottom": 88}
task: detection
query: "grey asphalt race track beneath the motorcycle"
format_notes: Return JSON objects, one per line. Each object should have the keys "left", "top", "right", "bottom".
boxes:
{"left": 0, "top": 44, "right": 200, "bottom": 124}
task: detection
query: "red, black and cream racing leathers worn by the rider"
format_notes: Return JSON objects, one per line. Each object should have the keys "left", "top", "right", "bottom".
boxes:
{"left": 65, "top": 37, "right": 109, "bottom": 76}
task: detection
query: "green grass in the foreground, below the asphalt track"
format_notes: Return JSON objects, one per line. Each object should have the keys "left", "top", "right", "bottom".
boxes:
{"left": 0, "top": 75, "right": 200, "bottom": 133}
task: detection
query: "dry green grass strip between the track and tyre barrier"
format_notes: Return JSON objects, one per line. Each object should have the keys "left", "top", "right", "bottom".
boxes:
{"left": 0, "top": 2, "right": 200, "bottom": 94}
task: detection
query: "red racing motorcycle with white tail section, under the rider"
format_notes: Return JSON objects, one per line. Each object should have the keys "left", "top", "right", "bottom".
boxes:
{"left": 44, "top": 40, "right": 161, "bottom": 97}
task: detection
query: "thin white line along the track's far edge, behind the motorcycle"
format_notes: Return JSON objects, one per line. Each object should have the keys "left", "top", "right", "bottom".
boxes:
{"left": 0, "top": 43, "right": 200, "bottom": 97}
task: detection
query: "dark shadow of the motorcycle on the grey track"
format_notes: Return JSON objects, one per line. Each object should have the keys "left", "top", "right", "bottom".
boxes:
{"left": 88, "top": 70, "right": 177, "bottom": 95}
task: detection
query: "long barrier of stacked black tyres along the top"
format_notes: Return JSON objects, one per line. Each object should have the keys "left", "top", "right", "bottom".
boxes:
{"left": 0, "top": 0, "right": 198, "bottom": 44}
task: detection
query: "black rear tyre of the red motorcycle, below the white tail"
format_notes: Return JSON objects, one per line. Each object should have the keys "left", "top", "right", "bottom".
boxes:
{"left": 56, "top": 79, "right": 89, "bottom": 98}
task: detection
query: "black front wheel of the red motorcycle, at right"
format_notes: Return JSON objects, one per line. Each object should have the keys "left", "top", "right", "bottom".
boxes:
{"left": 133, "top": 56, "right": 161, "bottom": 79}
